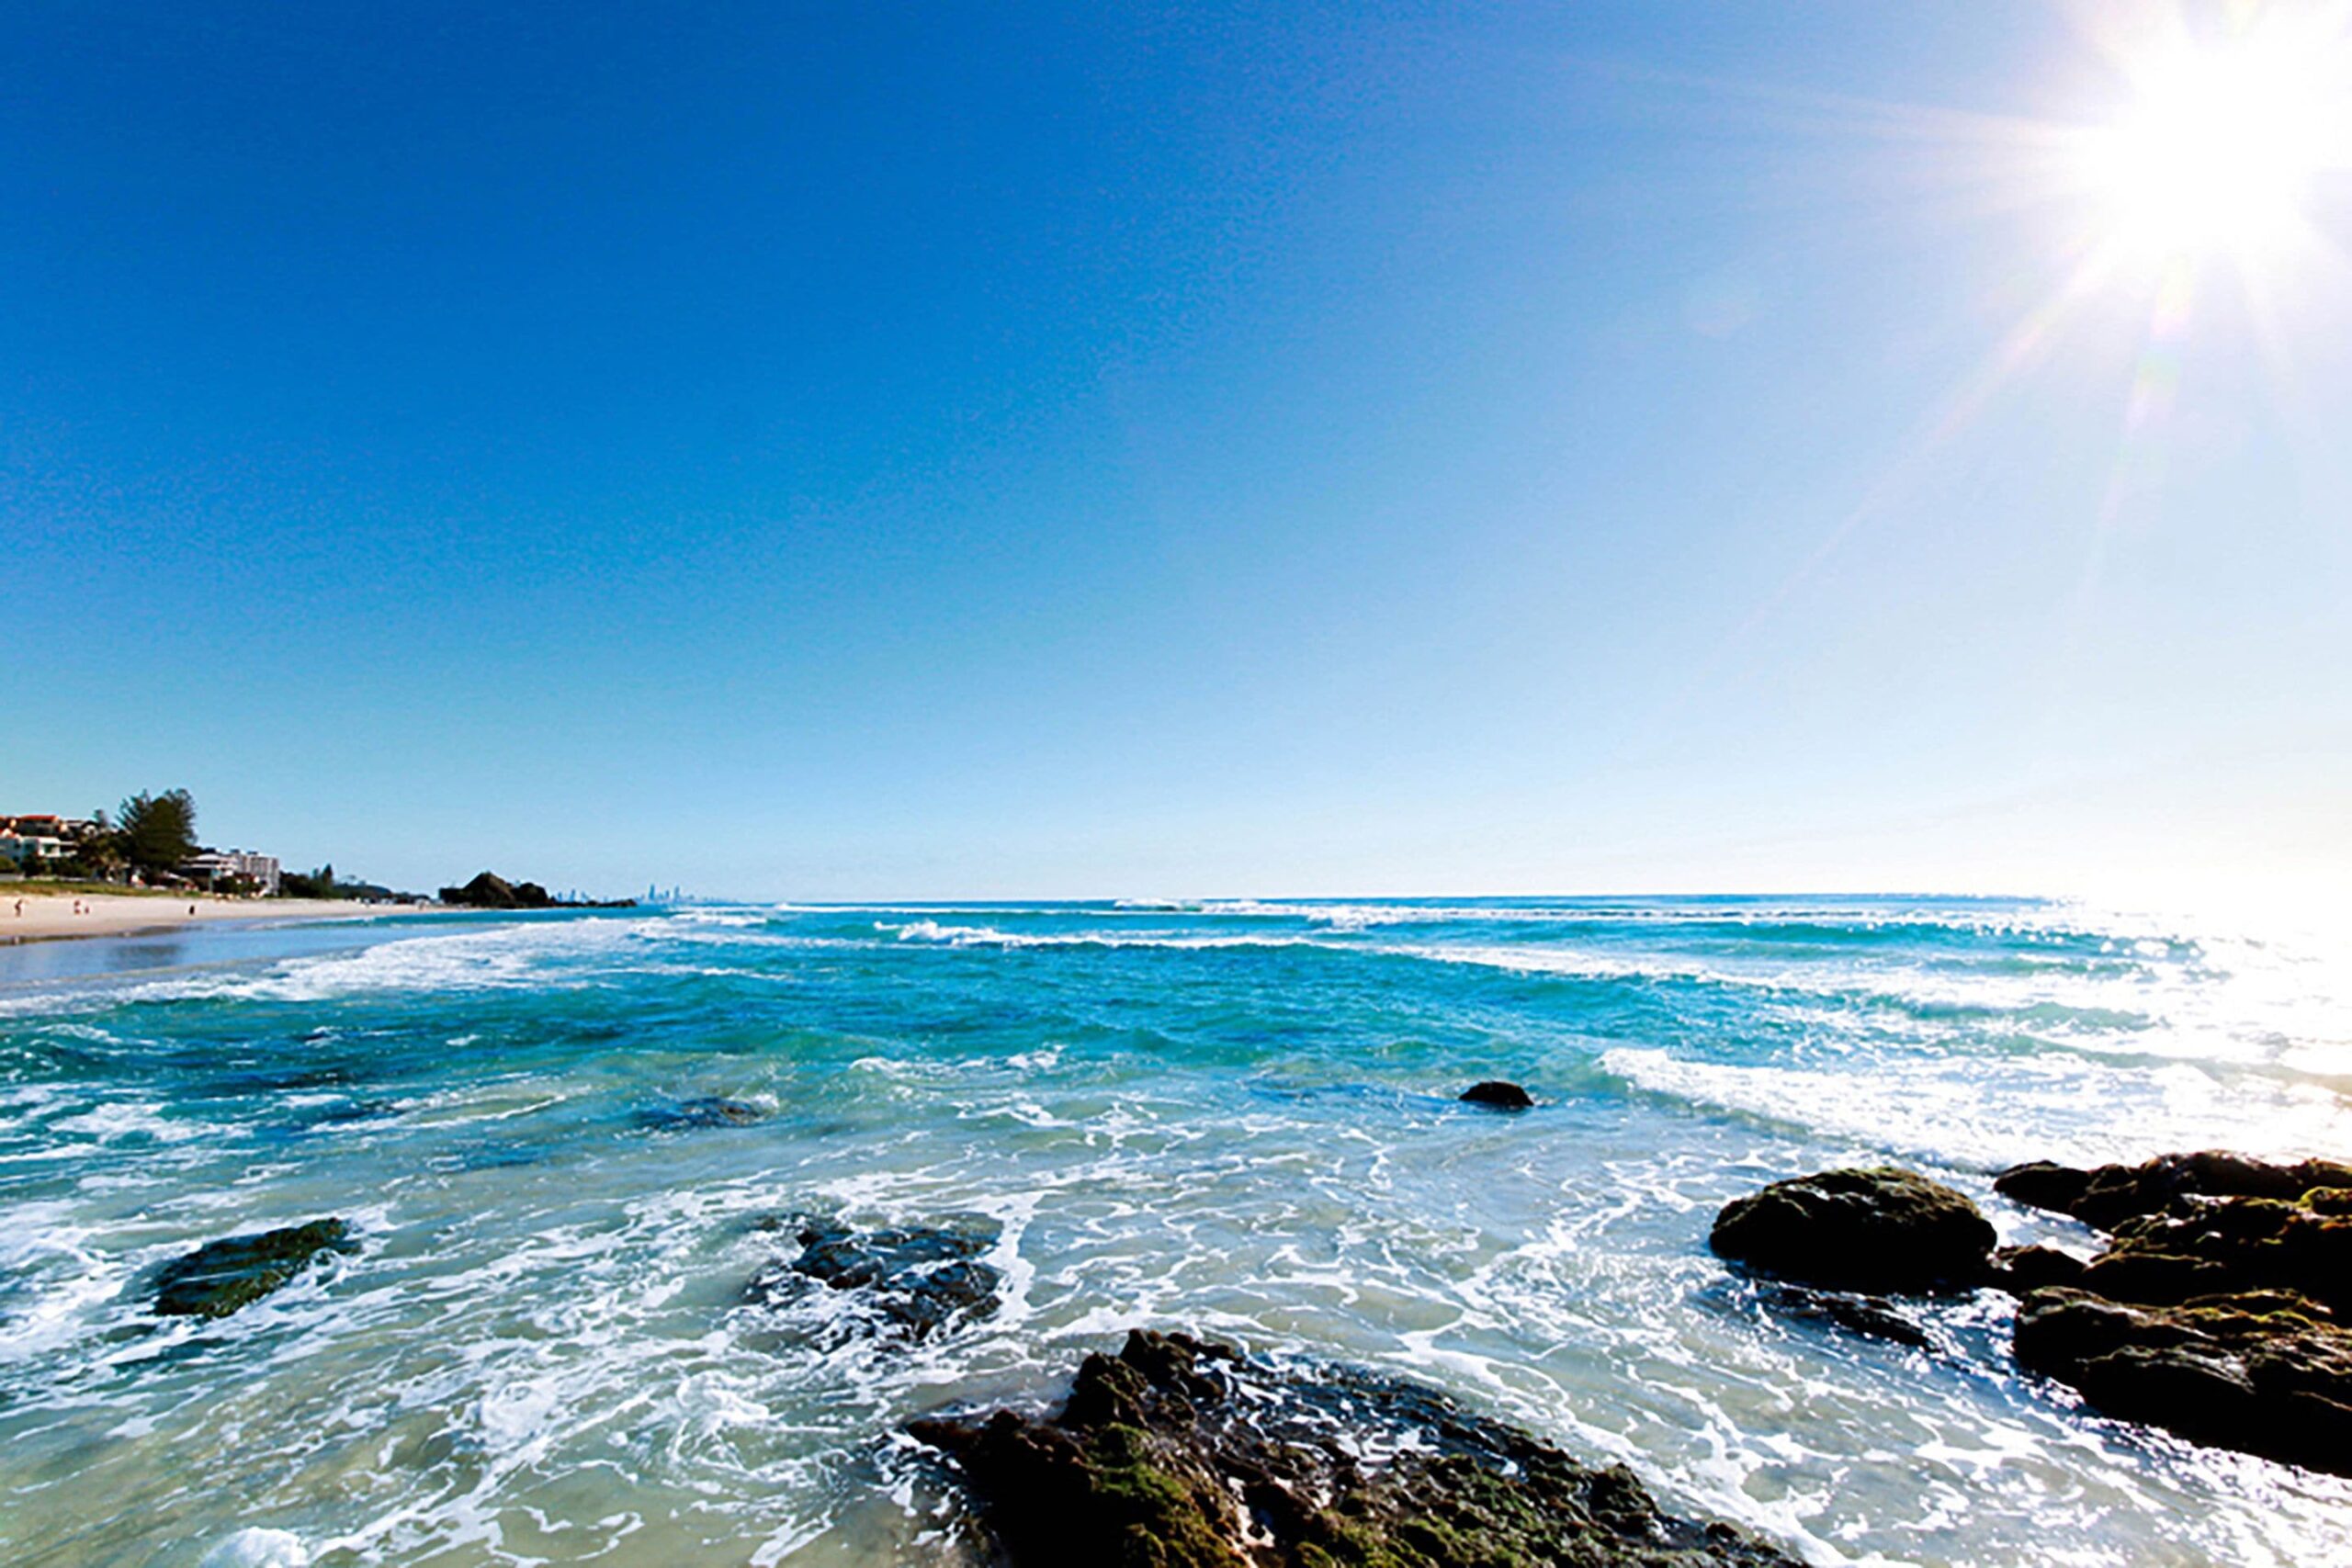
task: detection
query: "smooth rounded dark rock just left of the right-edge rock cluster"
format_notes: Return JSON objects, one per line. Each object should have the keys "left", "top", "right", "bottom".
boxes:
{"left": 1708, "top": 1168, "right": 1995, "bottom": 1291}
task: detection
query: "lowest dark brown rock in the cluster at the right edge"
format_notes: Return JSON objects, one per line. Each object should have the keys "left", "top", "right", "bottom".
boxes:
{"left": 2016, "top": 1286, "right": 2352, "bottom": 1474}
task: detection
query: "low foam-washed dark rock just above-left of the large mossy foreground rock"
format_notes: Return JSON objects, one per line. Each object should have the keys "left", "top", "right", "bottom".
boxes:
{"left": 746, "top": 1220, "right": 1004, "bottom": 1340}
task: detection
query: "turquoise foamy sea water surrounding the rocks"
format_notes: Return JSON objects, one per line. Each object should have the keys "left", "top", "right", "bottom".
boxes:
{"left": 0, "top": 900, "right": 2352, "bottom": 1565}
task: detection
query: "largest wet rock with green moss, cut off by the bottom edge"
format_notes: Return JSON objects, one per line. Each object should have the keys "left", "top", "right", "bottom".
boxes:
{"left": 910, "top": 1331, "right": 1794, "bottom": 1568}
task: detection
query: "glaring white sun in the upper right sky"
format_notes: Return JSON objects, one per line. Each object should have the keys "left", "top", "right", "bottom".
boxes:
{"left": 2076, "top": 38, "right": 2347, "bottom": 261}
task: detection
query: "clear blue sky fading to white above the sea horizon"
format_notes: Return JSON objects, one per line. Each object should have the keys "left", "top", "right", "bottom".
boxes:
{"left": 0, "top": 0, "right": 2352, "bottom": 898}
